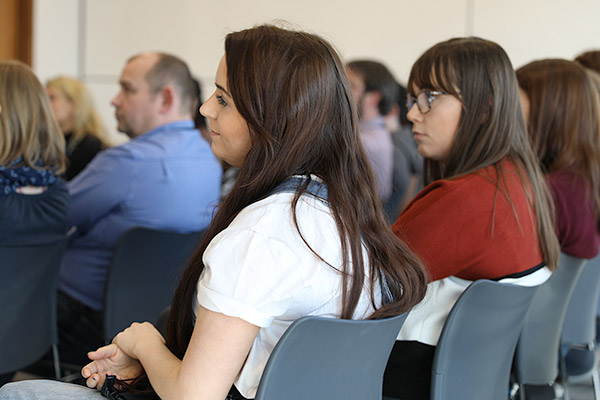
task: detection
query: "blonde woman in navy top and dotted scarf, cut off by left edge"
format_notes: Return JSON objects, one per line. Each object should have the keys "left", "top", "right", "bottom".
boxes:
{"left": 0, "top": 61, "right": 69, "bottom": 386}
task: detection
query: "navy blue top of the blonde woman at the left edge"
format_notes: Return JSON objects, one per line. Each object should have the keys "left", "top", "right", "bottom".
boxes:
{"left": 0, "top": 179, "right": 70, "bottom": 246}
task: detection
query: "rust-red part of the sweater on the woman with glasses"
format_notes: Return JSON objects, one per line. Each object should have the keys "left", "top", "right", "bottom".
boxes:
{"left": 392, "top": 160, "right": 543, "bottom": 281}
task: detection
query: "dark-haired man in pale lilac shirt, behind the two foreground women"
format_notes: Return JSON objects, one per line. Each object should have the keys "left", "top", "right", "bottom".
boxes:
{"left": 347, "top": 60, "right": 397, "bottom": 202}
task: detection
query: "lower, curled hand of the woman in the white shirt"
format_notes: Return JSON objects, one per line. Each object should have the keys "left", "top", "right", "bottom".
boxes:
{"left": 81, "top": 344, "right": 144, "bottom": 390}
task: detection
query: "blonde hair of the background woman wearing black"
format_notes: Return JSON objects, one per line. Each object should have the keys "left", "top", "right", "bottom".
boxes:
{"left": 46, "top": 76, "right": 109, "bottom": 147}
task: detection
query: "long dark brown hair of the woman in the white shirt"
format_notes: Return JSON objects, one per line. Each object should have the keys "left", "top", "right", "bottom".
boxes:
{"left": 167, "top": 25, "right": 427, "bottom": 357}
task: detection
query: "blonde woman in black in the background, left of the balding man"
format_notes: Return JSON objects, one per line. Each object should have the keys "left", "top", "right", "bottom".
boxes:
{"left": 46, "top": 76, "right": 108, "bottom": 181}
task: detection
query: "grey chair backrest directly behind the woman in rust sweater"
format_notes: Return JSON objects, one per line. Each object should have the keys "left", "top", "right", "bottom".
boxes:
{"left": 431, "top": 280, "right": 537, "bottom": 400}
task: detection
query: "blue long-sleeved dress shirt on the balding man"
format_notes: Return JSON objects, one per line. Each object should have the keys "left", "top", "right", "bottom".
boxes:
{"left": 59, "top": 120, "right": 221, "bottom": 310}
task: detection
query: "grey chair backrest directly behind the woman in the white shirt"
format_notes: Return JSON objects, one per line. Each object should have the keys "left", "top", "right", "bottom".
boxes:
{"left": 255, "top": 313, "right": 407, "bottom": 400}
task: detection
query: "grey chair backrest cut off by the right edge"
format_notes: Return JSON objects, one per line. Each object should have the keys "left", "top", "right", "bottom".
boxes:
{"left": 562, "top": 256, "right": 600, "bottom": 344}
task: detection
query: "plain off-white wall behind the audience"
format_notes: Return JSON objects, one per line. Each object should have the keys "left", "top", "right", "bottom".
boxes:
{"left": 33, "top": 0, "right": 600, "bottom": 142}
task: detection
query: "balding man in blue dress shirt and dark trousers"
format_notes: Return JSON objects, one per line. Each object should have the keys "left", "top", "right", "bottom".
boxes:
{"left": 58, "top": 53, "right": 221, "bottom": 364}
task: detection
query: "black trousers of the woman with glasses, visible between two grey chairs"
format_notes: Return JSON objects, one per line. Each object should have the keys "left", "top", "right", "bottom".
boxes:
{"left": 383, "top": 341, "right": 435, "bottom": 400}
